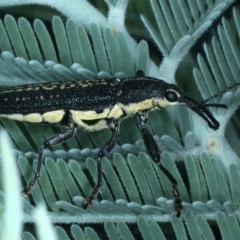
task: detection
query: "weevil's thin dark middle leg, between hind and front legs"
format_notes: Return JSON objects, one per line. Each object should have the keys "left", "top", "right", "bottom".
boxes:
{"left": 83, "top": 122, "right": 119, "bottom": 208}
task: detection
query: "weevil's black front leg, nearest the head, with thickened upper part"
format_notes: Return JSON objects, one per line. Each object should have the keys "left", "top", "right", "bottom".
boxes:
{"left": 137, "top": 114, "right": 183, "bottom": 217}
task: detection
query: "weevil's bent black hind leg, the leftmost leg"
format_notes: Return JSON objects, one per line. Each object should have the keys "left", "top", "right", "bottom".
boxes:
{"left": 22, "top": 127, "right": 77, "bottom": 196}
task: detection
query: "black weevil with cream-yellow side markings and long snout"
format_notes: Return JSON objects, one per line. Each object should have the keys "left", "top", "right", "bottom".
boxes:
{"left": 0, "top": 71, "right": 227, "bottom": 217}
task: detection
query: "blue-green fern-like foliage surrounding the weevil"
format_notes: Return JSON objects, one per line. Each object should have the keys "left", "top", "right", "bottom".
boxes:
{"left": 0, "top": 0, "right": 240, "bottom": 240}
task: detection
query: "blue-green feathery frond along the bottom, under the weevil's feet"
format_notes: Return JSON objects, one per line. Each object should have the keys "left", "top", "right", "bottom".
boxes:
{"left": 0, "top": 137, "right": 240, "bottom": 239}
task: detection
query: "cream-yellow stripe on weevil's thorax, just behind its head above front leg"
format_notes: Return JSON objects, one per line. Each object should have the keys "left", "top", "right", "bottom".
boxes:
{"left": 119, "top": 98, "right": 155, "bottom": 115}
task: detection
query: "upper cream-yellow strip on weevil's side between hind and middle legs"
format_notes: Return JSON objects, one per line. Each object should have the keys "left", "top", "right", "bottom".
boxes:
{"left": 70, "top": 109, "right": 110, "bottom": 120}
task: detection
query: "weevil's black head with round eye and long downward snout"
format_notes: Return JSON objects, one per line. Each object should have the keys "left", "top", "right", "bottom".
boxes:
{"left": 157, "top": 82, "right": 220, "bottom": 130}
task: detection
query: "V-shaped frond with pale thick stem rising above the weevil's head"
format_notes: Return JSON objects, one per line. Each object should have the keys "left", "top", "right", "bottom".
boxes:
{"left": 141, "top": 0, "right": 233, "bottom": 83}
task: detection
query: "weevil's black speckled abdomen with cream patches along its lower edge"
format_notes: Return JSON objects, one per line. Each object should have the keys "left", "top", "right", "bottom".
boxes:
{"left": 0, "top": 79, "right": 120, "bottom": 123}
